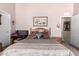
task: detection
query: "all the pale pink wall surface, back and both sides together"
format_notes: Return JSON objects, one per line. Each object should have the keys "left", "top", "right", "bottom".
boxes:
{"left": 0, "top": 3, "right": 79, "bottom": 36}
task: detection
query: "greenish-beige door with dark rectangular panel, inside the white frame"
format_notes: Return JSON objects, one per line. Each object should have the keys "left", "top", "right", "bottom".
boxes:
{"left": 62, "top": 17, "right": 71, "bottom": 43}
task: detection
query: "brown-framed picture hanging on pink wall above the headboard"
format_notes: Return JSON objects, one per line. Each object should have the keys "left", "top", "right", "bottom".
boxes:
{"left": 33, "top": 16, "right": 48, "bottom": 26}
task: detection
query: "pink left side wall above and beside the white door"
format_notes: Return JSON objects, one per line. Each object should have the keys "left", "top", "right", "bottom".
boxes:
{"left": 0, "top": 3, "right": 15, "bottom": 32}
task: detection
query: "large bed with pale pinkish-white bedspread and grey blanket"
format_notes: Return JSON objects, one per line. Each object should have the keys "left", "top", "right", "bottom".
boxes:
{"left": 1, "top": 39, "right": 74, "bottom": 56}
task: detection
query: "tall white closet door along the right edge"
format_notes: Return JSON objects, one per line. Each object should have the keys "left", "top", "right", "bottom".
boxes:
{"left": 71, "top": 14, "right": 79, "bottom": 48}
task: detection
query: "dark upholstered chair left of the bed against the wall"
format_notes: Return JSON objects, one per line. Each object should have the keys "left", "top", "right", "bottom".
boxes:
{"left": 10, "top": 30, "right": 28, "bottom": 44}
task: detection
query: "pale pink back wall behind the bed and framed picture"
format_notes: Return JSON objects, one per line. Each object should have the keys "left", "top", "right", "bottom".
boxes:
{"left": 15, "top": 3, "right": 73, "bottom": 37}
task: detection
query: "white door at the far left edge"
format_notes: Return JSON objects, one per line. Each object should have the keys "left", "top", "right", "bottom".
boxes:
{"left": 0, "top": 14, "right": 11, "bottom": 47}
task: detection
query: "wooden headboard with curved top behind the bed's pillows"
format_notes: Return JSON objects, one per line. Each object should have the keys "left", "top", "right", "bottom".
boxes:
{"left": 30, "top": 28, "right": 51, "bottom": 38}
